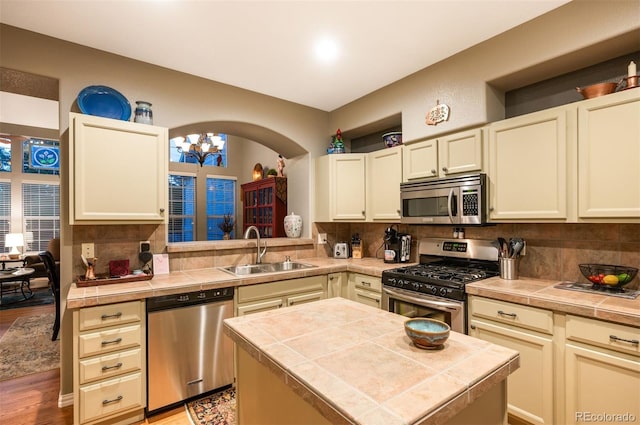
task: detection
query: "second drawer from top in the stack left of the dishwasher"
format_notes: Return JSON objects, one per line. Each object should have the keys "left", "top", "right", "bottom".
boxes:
{"left": 78, "top": 324, "right": 142, "bottom": 358}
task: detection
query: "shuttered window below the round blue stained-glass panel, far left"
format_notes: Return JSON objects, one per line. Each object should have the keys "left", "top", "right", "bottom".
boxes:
{"left": 22, "top": 183, "right": 60, "bottom": 252}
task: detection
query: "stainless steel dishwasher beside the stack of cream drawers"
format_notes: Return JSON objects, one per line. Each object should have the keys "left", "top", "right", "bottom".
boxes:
{"left": 147, "top": 288, "right": 233, "bottom": 414}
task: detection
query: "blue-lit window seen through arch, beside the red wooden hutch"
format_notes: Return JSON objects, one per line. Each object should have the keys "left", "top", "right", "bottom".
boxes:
{"left": 207, "top": 177, "right": 236, "bottom": 241}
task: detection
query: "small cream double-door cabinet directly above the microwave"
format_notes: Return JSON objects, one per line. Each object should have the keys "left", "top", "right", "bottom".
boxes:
{"left": 402, "top": 128, "right": 483, "bottom": 182}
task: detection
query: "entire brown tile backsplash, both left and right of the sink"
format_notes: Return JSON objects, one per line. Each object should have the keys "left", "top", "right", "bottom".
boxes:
{"left": 73, "top": 223, "right": 640, "bottom": 287}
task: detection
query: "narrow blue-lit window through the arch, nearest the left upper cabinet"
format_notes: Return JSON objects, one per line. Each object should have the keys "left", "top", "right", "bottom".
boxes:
{"left": 168, "top": 174, "right": 196, "bottom": 242}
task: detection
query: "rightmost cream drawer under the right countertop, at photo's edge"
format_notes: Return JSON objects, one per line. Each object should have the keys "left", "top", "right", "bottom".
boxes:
{"left": 566, "top": 315, "right": 640, "bottom": 356}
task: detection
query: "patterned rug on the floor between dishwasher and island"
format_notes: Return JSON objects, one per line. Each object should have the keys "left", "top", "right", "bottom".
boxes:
{"left": 187, "top": 388, "right": 236, "bottom": 425}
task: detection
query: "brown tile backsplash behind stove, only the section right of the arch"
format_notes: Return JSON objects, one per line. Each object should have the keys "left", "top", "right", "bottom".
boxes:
{"left": 313, "top": 223, "right": 640, "bottom": 287}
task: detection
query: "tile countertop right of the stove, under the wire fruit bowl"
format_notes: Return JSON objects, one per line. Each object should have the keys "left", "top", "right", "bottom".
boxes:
{"left": 465, "top": 277, "right": 640, "bottom": 327}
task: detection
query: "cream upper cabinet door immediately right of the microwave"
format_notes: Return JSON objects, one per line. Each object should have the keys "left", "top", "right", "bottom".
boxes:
{"left": 489, "top": 107, "right": 576, "bottom": 222}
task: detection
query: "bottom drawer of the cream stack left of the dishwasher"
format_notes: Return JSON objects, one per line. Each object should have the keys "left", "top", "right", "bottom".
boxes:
{"left": 79, "top": 373, "right": 144, "bottom": 423}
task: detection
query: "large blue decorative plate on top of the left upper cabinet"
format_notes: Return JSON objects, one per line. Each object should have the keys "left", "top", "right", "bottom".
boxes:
{"left": 77, "top": 86, "right": 131, "bottom": 121}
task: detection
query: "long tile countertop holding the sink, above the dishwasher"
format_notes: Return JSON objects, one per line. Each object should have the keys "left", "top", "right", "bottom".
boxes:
{"left": 67, "top": 258, "right": 415, "bottom": 309}
